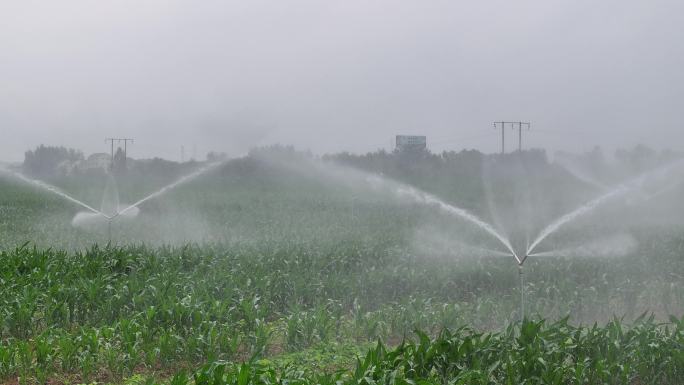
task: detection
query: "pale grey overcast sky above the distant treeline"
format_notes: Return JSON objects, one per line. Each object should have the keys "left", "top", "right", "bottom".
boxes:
{"left": 0, "top": 0, "right": 684, "bottom": 161}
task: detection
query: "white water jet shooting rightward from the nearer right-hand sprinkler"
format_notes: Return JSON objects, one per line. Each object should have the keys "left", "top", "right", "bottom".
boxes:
{"left": 525, "top": 160, "right": 684, "bottom": 255}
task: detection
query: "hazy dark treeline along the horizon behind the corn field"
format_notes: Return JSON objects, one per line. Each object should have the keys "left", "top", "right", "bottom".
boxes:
{"left": 23, "top": 145, "right": 682, "bottom": 186}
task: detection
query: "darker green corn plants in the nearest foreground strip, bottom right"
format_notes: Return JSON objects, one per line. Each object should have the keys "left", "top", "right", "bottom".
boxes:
{"left": 182, "top": 319, "right": 684, "bottom": 385}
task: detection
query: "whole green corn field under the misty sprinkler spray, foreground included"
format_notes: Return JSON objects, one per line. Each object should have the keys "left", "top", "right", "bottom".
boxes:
{"left": 0, "top": 154, "right": 684, "bottom": 385}
